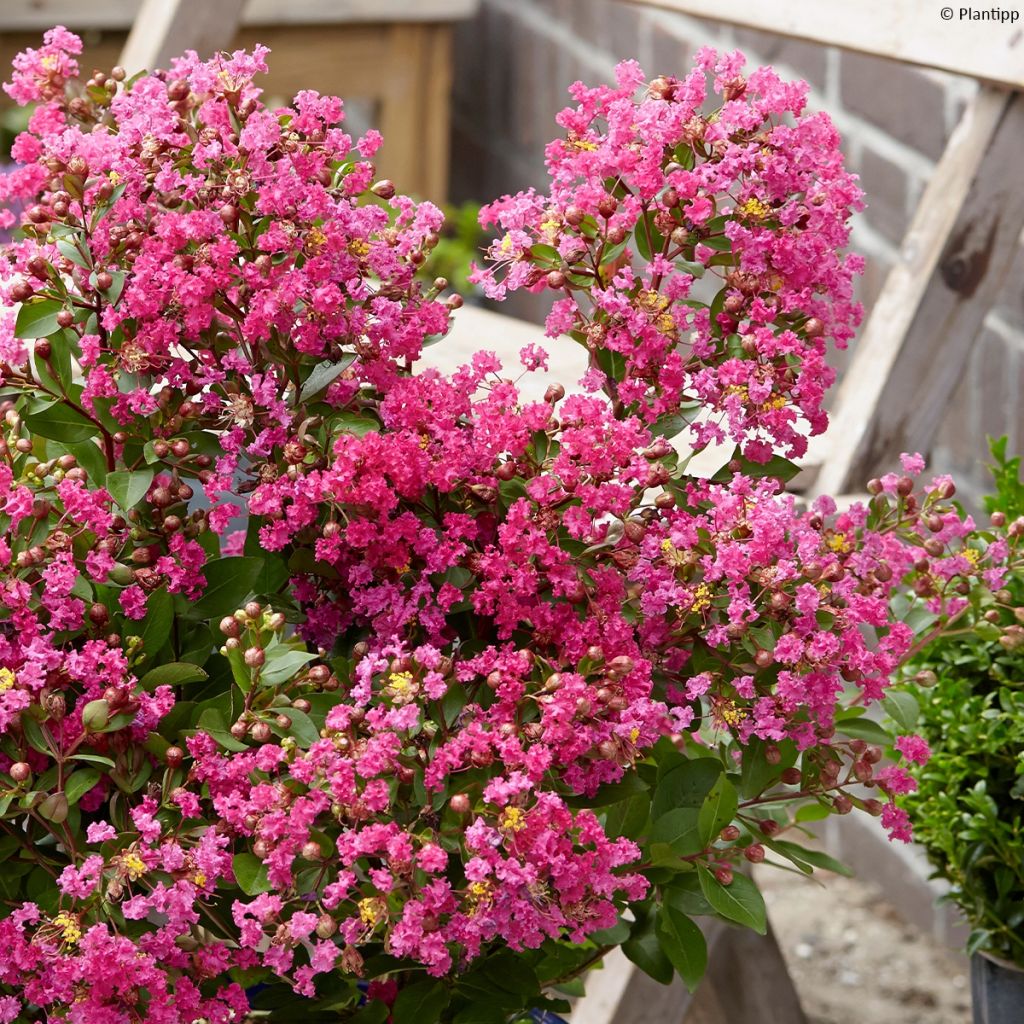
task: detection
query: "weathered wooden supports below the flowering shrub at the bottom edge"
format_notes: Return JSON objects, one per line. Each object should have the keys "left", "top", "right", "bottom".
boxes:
{"left": 569, "top": 921, "right": 806, "bottom": 1024}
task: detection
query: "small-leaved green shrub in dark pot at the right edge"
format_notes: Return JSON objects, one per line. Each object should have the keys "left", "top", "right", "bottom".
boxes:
{"left": 892, "top": 437, "right": 1024, "bottom": 1024}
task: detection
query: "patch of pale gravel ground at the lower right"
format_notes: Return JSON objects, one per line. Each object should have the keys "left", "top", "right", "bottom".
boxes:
{"left": 757, "top": 868, "right": 971, "bottom": 1024}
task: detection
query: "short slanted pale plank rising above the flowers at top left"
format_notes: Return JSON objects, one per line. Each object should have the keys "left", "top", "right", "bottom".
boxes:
{"left": 120, "top": 0, "right": 246, "bottom": 75}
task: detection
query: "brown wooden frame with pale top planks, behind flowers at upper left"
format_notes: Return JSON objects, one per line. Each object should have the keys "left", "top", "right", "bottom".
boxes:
{"left": 0, "top": 0, "right": 471, "bottom": 201}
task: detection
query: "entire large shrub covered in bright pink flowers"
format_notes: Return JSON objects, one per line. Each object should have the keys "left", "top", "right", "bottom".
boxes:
{"left": 0, "top": 29, "right": 1005, "bottom": 1024}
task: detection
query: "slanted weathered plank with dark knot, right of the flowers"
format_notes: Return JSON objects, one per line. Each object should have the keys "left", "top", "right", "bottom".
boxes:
{"left": 808, "top": 88, "right": 1024, "bottom": 495}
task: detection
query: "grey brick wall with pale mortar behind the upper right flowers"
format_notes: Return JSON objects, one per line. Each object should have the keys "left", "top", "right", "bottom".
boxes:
{"left": 453, "top": 0, "right": 1024, "bottom": 496}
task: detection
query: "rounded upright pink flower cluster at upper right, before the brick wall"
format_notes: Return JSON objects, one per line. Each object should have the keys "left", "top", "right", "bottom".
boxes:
{"left": 476, "top": 49, "right": 863, "bottom": 462}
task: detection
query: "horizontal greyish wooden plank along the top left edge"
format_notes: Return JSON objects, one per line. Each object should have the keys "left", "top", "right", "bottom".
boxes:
{"left": 0, "top": 0, "right": 480, "bottom": 32}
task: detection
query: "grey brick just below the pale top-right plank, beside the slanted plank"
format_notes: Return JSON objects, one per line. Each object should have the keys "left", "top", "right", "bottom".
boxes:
{"left": 840, "top": 52, "right": 946, "bottom": 159}
